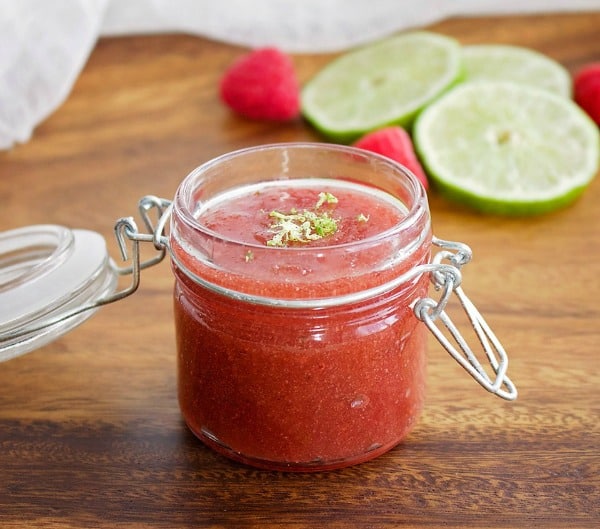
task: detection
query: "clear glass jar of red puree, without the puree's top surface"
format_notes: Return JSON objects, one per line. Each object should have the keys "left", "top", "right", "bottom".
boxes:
{"left": 170, "top": 144, "right": 431, "bottom": 471}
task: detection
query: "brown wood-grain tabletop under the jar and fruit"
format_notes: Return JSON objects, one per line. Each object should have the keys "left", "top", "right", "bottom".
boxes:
{"left": 0, "top": 12, "right": 600, "bottom": 529}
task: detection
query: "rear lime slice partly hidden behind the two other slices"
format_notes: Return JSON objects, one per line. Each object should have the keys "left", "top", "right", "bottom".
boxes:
{"left": 463, "top": 44, "right": 572, "bottom": 97}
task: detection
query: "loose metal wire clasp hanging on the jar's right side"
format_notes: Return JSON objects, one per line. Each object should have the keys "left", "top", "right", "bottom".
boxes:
{"left": 413, "top": 237, "right": 517, "bottom": 400}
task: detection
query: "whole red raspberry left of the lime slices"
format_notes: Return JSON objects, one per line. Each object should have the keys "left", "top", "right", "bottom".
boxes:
{"left": 220, "top": 48, "right": 300, "bottom": 121}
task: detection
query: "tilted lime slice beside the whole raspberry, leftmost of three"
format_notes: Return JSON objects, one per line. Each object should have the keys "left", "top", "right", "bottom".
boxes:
{"left": 301, "top": 31, "right": 462, "bottom": 142}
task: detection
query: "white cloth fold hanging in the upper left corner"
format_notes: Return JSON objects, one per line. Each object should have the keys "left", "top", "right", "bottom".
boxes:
{"left": 0, "top": 0, "right": 108, "bottom": 149}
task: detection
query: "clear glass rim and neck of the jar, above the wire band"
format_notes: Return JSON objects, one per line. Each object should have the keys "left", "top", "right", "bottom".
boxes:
{"left": 169, "top": 142, "right": 431, "bottom": 308}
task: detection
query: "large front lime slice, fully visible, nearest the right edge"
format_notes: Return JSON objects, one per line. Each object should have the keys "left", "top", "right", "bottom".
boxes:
{"left": 414, "top": 81, "right": 600, "bottom": 215}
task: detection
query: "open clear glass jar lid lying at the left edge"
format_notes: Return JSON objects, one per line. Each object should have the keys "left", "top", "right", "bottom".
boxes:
{"left": 0, "top": 225, "right": 117, "bottom": 361}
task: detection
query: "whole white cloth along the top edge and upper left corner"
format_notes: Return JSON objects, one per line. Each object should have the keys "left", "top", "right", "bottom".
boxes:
{"left": 0, "top": 0, "right": 600, "bottom": 149}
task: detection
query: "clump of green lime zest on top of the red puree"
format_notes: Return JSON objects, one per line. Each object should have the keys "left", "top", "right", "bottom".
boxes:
{"left": 267, "top": 192, "right": 338, "bottom": 246}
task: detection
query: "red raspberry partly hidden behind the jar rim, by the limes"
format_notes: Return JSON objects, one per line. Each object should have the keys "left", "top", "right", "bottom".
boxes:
{"left": 354, "top": 126, "right": 429, "bottom": 189}
